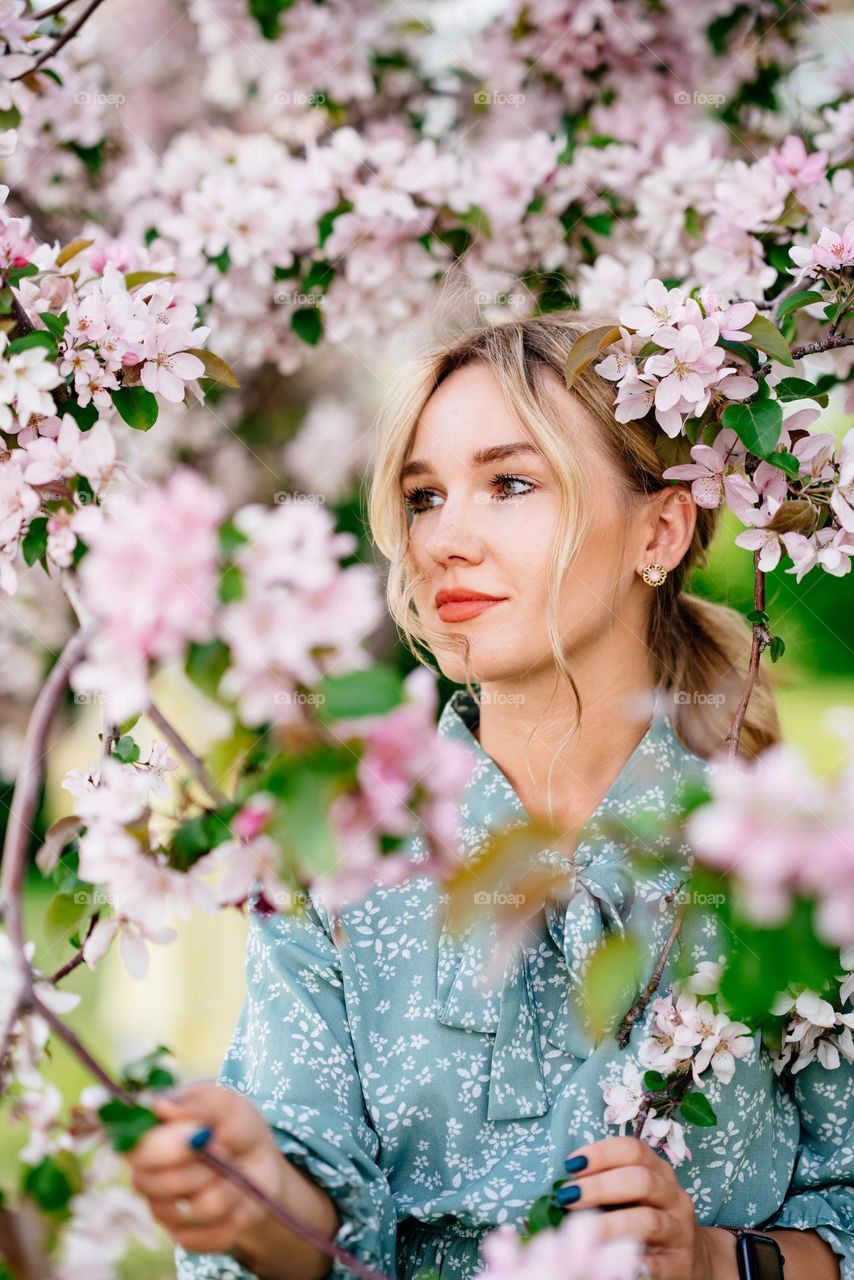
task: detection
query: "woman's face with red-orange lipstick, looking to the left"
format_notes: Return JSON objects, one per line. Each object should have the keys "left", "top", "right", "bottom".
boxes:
{"left": 402, "top": 364, "right": 656, "bottom": 684}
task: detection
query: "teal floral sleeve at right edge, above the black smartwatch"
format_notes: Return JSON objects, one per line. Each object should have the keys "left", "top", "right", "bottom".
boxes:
{"left": 763, "top": 1060, "right": 854, "bottom": 1280}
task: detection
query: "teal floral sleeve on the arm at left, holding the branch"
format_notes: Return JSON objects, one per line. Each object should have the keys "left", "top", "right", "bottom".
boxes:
{"left": 175, "top": 902, "right": 397, "bottom": 1280}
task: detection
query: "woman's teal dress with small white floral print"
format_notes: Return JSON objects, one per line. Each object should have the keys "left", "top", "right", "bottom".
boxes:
{"left": 175, "top": 690, "right": 854, "bottom": 1280}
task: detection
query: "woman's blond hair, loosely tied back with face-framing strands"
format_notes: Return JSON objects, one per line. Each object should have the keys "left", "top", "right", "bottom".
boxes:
{"left": 369, "top": 311, "right": 780, "bottom": 794}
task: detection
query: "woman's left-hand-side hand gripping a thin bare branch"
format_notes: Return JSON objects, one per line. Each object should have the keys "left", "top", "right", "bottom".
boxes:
{"left": 127, "top": 1083, "right": 286, "bottom": 1253}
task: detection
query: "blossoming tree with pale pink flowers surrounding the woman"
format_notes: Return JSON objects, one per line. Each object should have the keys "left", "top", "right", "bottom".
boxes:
{"left": 0, "top": 0, "right": 854, "bottom": 1280}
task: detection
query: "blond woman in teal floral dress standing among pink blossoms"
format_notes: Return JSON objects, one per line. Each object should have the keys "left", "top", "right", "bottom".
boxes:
{"left": 131, "top": 314, "right": 854, "bottom": 1280}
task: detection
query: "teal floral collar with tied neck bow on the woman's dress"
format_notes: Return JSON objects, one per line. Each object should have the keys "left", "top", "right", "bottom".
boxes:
{"left": 437, "top": 689, "right": 705, "bottom": 1120}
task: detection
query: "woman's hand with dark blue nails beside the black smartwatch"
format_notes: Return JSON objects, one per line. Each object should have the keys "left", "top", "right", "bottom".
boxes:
{"left": 558, "top": 1138, "right": 734, "bottom": 1280}
